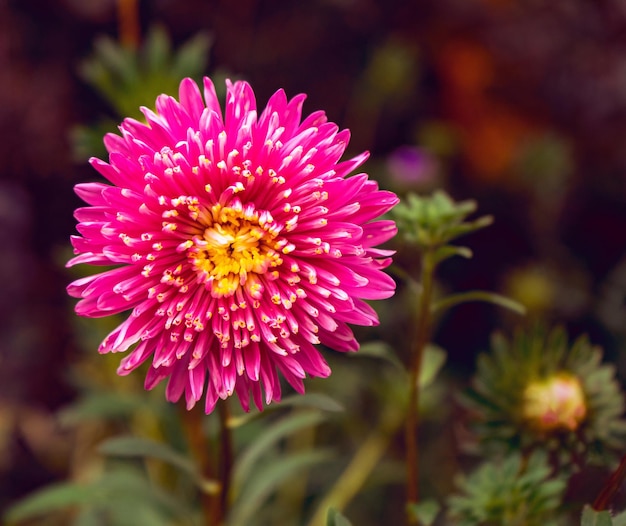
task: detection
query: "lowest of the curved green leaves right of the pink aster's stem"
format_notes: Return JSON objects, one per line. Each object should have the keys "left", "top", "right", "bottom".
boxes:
{"left": 227, "top": 450, "right": 331, "bottom": 526}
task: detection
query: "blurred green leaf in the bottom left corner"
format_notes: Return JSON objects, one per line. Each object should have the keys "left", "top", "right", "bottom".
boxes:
{"left": 4, "top": 482, "right": 101, "bottom": 524}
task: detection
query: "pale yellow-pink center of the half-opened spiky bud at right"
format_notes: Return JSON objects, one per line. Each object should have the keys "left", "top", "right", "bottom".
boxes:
{"left": 523, "top": 373, "right": 587, "bottom": 432}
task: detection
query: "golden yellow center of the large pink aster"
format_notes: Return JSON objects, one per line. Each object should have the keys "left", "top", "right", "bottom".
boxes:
{"left": 188, "top": 205, "right": 282, "bottom": 298}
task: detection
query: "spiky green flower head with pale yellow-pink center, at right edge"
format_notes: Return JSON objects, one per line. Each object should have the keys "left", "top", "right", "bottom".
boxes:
{"left": 464, "top": 328, "right": 626, "bottom": 467}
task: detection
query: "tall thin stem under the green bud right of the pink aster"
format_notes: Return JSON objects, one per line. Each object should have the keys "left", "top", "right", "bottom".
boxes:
{"left": 405, "top": 248, "right": 436, "bottom": 524}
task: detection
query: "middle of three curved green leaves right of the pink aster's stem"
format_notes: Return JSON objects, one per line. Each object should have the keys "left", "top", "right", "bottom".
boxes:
{"left": 233, "top": 411, "right": 326, "bottom": 491}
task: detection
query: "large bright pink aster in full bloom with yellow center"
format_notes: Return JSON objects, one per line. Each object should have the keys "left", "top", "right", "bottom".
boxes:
{"left": 68, "top": 78, "right": 398, "bottom": 413}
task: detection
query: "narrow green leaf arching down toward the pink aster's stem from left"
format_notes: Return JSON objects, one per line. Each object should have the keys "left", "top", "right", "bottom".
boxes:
{"left": 98, "top": 436, "right": 200, "bottom": 481}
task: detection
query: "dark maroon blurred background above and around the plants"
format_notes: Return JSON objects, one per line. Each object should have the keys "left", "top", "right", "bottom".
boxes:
{"left": 0, "top": 0, "right": 626, "bottom": 520}
